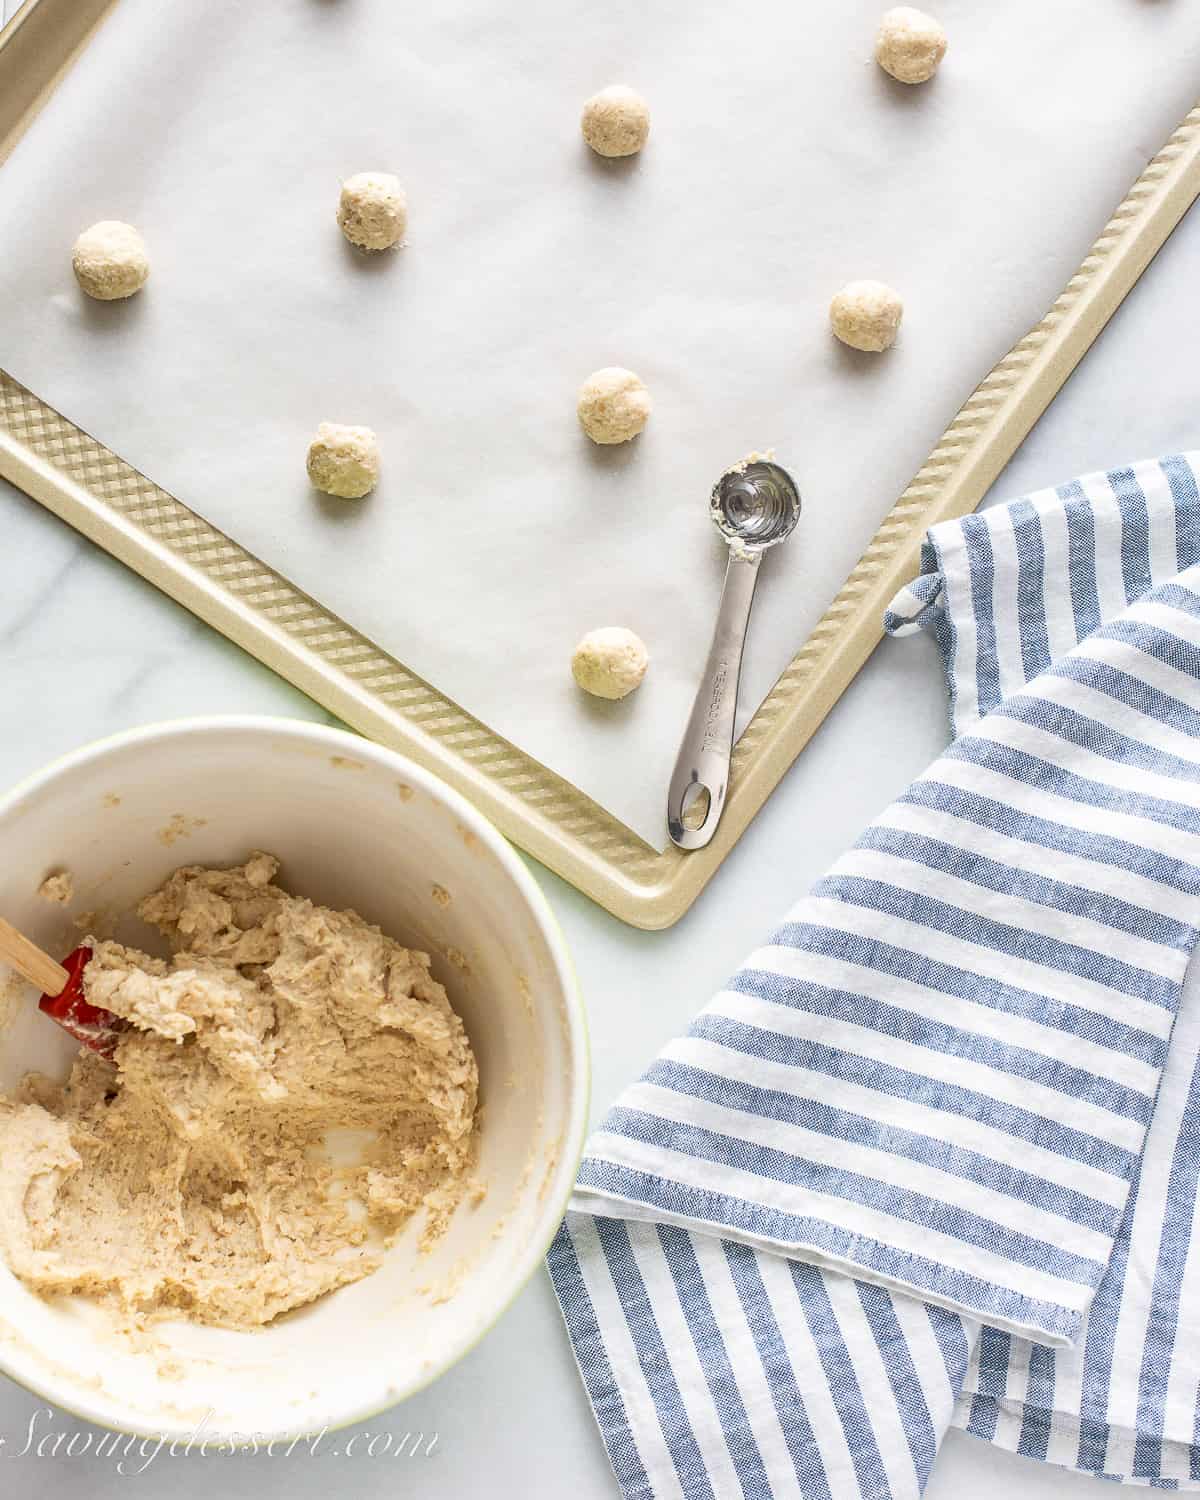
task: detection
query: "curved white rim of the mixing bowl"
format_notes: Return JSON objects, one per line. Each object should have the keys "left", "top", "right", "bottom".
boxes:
{"left": 0, "top": 714, "right": 591, "bottom": 1448}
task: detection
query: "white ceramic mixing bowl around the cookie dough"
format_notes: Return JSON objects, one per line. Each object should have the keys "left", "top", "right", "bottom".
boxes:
{"left": 0, "top": 717, "right": 587, "bottom": 1439}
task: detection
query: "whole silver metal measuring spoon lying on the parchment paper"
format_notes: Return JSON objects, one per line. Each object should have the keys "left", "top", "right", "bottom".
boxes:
{"left": 666, "top": 459, "right": 800, "bottom": 849}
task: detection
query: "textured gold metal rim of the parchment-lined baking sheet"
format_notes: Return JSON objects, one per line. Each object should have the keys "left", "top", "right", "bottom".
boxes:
{"left": 0, "top": 0, "right": 1200, "bottom": 929}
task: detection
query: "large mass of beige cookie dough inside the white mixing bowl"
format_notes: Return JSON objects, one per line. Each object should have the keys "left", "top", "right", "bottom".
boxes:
{"left": 0, "top": 854, "right": 479, "bottom": 1328}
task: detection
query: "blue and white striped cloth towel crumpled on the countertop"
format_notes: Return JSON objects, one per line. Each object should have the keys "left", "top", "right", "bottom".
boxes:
{"left": 549, "top": 458, "right": 1200, "bottom": 1500}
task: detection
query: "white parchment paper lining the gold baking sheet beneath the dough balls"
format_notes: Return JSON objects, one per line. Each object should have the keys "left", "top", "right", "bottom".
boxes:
{"left": 0, "top": 0, "right": 1200, "bottom": 848}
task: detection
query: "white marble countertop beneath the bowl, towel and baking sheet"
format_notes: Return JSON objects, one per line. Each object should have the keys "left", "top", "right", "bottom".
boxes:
{"left": 0, "top": 0, "right": 1200, "bottom": 1500}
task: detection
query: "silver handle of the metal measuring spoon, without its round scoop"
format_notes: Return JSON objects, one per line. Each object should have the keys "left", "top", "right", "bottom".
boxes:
{"left": 666, "top": 549, "right": 762, "bottom": 849}
